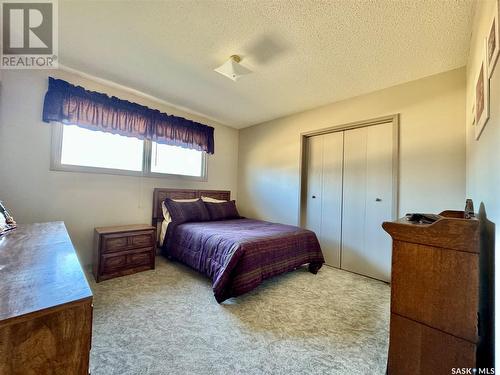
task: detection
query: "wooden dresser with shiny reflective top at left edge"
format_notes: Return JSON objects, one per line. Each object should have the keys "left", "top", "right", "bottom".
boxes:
{"left": 0, "top": 222, "right": 92, "bottom": 375}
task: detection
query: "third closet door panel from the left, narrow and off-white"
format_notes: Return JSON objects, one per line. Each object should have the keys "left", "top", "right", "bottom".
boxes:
{"left": 341, "top": 128, "right": 366, "bottom": 273}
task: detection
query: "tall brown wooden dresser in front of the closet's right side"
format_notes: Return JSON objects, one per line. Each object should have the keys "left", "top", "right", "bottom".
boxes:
{"left": 383, "top": 211, "right": 492, "bottom": 375}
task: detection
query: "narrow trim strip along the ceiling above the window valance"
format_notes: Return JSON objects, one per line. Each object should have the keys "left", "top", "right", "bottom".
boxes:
{"left": 59, "top": 63, "right": 228, "bottom": 129}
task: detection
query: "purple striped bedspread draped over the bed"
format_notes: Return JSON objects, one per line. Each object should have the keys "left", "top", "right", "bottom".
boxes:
{"left": 163, "top": 219, "right": 324, "bottom": 303}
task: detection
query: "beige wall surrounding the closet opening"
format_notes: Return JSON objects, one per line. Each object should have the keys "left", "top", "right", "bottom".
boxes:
{"left": 238, "top": 68, "right": 465, "bottom": 224}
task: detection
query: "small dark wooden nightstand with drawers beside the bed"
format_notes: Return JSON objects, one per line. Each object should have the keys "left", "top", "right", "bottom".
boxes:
{"left": 92, "top": 224, "right": 156, "bottom": 282}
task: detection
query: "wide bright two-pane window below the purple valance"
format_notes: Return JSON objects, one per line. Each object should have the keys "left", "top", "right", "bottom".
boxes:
{"left": 51, "top": 124, "right": 206, "bottom": 180}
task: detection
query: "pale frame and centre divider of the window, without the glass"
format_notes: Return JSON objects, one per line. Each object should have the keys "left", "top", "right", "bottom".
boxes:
{"left": 50, "top": 123, "right": 208, "bottom": 182}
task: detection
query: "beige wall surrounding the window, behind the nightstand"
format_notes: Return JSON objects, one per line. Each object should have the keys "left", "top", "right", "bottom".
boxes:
{"left": 0, "top": 71, "right": 238, "bottom": 264}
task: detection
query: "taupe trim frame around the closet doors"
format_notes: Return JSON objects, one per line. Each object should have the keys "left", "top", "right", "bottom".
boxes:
{"left": 297, "top": 113, "right": 399, "bottom": 231}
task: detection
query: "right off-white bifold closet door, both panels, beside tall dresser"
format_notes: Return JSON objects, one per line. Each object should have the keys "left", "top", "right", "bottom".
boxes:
{"left": 341, "top": 123, "right": 393, "bottom": 281}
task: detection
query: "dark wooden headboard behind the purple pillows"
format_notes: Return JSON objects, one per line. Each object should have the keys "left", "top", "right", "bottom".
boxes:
{"left": 151, "top": 188, "right": 231, "bottom": 226}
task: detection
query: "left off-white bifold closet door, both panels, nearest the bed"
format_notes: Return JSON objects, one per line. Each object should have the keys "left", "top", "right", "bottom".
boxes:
{"left": 305, "top": 132, "right": 344, "bottom": 267}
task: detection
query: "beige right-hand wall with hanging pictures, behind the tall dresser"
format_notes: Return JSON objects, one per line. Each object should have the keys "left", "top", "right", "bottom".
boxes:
{"left": 467, "top": 1, "right": 500, "bottom": 362}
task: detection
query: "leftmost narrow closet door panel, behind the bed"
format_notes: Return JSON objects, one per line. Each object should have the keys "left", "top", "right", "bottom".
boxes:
{"left": 305, "top": 136, "right": 323, "bottom": 238}
